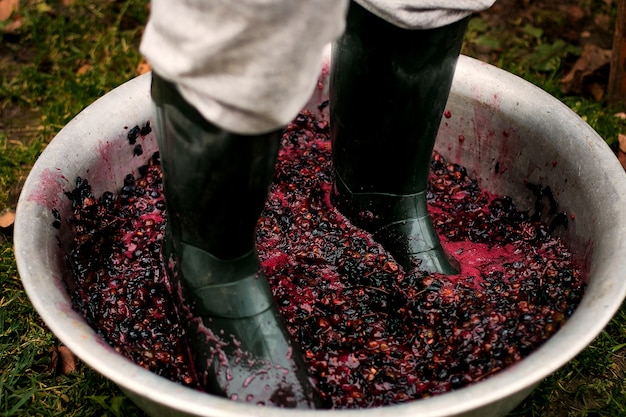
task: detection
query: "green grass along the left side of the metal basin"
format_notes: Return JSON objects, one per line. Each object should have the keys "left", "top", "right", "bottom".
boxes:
{"left": 0, "top": 0, "right": 148, "bottom": 417}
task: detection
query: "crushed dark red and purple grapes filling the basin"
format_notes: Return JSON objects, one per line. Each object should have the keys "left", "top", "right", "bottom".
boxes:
{"left": 61, "top": 109, "right": 584, "bottom": 408}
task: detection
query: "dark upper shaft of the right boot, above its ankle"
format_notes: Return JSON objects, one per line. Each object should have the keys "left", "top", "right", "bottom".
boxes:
{"left": 330, "top": 2, "right": 467, "bottom": 195}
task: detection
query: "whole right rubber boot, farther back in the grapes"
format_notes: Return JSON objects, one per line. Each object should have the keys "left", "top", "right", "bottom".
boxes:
{"left": 330, "top": 2, "right": 467, "bottom": 274}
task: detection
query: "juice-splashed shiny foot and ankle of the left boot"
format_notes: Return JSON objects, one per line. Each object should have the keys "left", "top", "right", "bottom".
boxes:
{"left": 171, "top": 245, "right": 317, "bottom": 408}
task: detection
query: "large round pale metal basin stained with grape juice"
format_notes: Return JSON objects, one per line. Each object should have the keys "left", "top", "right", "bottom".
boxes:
{"left": 15, "top": 55, "right": 626, "bottom": 417}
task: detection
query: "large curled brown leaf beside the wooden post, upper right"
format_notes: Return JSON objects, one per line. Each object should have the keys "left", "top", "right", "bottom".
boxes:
{"left": 561, "top": 44, "right": 611, "bottom": 100}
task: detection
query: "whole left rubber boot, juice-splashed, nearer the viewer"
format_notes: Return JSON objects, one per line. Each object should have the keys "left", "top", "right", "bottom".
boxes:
{"left": 152, "top": 74, "right": 316, "bottom": 408}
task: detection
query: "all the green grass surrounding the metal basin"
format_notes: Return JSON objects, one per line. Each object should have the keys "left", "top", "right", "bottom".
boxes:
{"left": 0, "top": 0, "right": 626, "bottom": 417}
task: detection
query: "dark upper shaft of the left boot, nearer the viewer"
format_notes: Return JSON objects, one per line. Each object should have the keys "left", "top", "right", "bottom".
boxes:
{"left": 152, "top": 74, "right": 281, "bottom": 259}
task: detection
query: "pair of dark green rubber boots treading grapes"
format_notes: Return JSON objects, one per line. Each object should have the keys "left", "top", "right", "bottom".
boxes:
{"left": 152, "top": 4, "right": 467, "bottom": 408}
